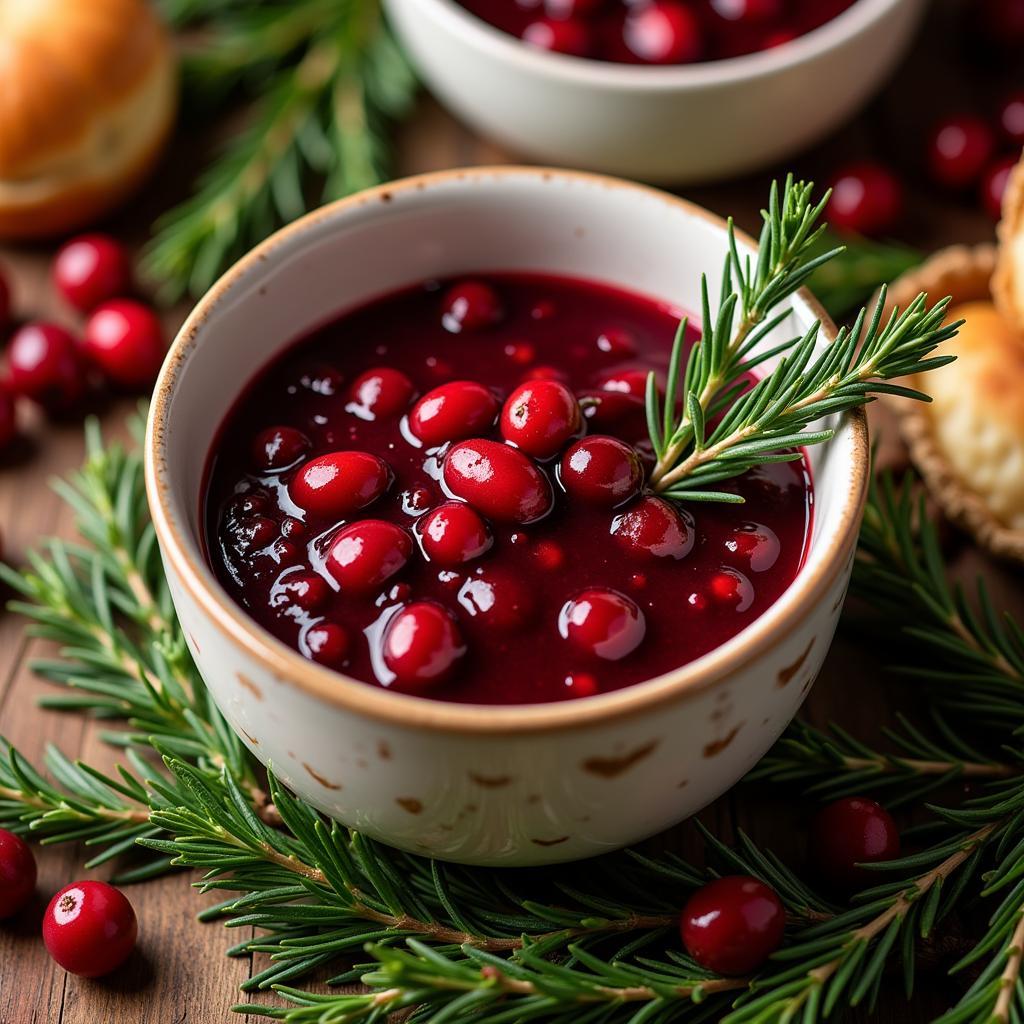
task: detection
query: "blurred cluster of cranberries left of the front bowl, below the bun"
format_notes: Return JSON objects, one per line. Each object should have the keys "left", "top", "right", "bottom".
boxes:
{"left": 0, "top": 234, "right": 165, "bottom": 449}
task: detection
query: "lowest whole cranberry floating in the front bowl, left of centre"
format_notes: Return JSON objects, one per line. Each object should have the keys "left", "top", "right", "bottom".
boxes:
{"left": 382, "top": 601, "right": 466, "bottom": 693}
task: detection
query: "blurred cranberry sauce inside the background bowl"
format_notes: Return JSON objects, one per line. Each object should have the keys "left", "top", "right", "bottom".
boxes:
{"left": 459, "top": 0, "right": 854, "bottom": 65}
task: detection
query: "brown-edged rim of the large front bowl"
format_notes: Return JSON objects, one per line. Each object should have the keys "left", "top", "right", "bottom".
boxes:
{"left": 144, "top": 165, "right": 869, "bottom": 735}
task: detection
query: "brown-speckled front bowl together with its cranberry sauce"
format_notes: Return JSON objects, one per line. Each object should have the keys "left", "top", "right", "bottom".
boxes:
{"left": 146, "top": 168, "right": 867, "bottom": 864}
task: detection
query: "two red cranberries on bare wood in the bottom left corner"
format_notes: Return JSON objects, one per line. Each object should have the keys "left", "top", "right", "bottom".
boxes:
{"left": 0, "top": 828, "right": 138, "bottom": 978}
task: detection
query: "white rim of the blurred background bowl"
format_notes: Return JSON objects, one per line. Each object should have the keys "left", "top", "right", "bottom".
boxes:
{"left": 391, "top": 0, "right": 915, "bottom": 92}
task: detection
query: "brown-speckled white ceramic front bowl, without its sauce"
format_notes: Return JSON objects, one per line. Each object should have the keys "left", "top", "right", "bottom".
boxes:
{"left": 146, "top": 168, "right": 867, "bottom": 864}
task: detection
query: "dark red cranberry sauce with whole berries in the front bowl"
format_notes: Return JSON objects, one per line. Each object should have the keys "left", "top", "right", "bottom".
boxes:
{"left": 205, "top": 273, "right": 811, "bottom": 703}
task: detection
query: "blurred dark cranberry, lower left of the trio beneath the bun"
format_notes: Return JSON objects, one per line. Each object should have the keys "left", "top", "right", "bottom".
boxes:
{"left": 7, "top": 321, "right": 85, "bottom": 412}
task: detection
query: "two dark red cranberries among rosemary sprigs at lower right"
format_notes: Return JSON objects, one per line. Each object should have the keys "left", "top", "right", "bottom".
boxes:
{"left": 680, "top": 797, "right": 900, "bottom": 976}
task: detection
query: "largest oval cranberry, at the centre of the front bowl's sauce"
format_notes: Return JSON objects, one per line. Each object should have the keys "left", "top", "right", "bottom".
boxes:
{"left": 443, "top": 439, "right": 553, "bottom": 523}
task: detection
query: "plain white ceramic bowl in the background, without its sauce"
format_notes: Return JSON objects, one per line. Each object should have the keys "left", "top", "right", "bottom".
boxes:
{"left": 385, "top": 0, "right": 926, "bottom": 183}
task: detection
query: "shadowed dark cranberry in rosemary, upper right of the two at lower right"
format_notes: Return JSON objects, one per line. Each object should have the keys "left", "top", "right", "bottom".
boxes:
{"left": 811, "top": 797, "right": 900, "bottom": 892}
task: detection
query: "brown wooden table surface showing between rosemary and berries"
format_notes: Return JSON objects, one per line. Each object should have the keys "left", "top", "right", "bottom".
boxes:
{"left": 0, "top": 0, "right": 1022, "bottom": 1024}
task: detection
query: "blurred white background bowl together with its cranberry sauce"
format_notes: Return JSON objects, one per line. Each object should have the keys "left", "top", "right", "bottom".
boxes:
{"left": 385, "top": 0, "right": 925, "bottom": 183}
